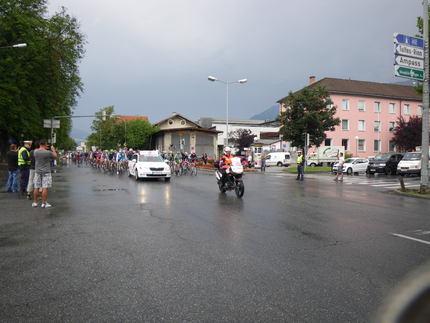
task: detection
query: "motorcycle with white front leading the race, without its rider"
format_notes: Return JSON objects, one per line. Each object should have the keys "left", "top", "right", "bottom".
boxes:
{"left": 215, "top": 157, "right": 245, "bottom": 198}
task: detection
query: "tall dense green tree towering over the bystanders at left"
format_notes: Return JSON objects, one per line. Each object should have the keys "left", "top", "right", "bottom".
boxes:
{"left": 0, "top": 0, "right": 85, "bottom": 157}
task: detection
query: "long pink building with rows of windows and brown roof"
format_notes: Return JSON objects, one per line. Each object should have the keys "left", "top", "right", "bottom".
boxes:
{"left": 278, "top": 77, "right": 422, "bottom": 157}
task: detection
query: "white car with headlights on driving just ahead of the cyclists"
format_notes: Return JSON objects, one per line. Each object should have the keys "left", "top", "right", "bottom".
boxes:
{"left": 128, "top": 150, "right": 172, "bottom": 182}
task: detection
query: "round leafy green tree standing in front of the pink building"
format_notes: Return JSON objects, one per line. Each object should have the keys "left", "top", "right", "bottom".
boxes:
{"left": 280, "top": 87, "right": 340, "bottom": 149}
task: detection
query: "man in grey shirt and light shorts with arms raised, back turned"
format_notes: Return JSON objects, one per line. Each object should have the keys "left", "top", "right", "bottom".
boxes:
{"left": 31, "top": 139, "right": 57, "bottom": 208}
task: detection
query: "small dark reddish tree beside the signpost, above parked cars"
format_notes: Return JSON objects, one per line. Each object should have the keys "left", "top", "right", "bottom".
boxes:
{"left": 393, "top": 116, "right": 423, "bottom": 151}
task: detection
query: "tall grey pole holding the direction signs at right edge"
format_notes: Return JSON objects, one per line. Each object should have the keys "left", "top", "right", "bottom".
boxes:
{"left": 420, "top": 0, "right": 430, "bottom": 193}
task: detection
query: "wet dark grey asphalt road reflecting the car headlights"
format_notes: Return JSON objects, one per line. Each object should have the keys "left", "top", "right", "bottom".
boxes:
{"left": 0, "top": 167, "right": 430, "bottom": 322}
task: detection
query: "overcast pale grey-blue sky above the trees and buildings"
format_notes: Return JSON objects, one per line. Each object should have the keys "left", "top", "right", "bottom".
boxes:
{"left": 48, "top": 0, "right": 422, "bottom": 138}
